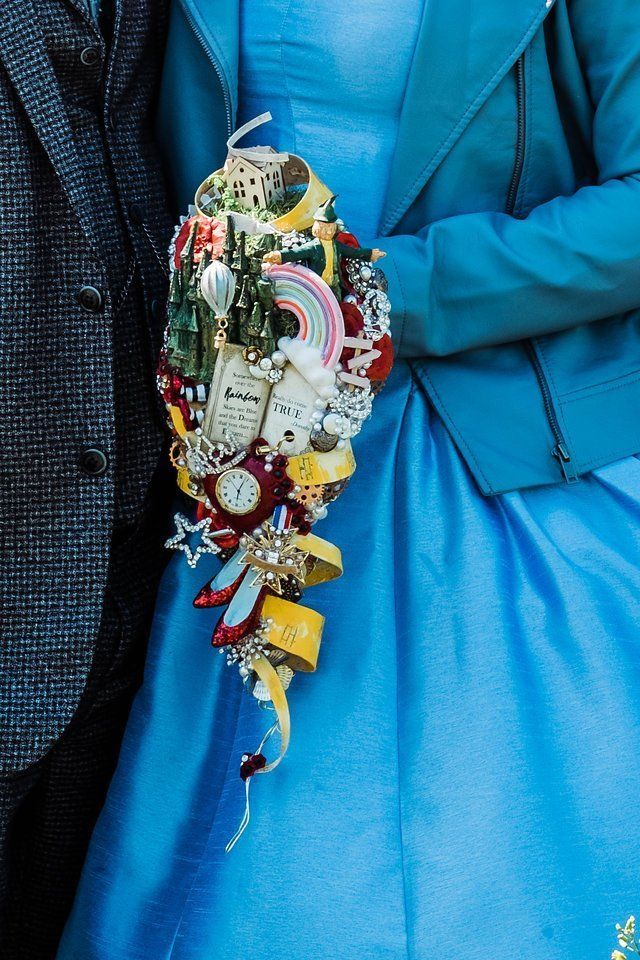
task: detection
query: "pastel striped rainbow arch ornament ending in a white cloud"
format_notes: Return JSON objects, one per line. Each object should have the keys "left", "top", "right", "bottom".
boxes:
{"left": 267, "top": 263, "right": 344, "bottom": 370}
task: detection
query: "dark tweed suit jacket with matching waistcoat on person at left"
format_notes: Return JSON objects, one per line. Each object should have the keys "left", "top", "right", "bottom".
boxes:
{"left": 0, "top": 0, "right": 171, "bottom": 772}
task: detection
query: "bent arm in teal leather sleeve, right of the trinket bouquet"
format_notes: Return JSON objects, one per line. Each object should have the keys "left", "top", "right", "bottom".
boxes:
{"left": 377, "top": 0, "right": 640, "bottom": 357}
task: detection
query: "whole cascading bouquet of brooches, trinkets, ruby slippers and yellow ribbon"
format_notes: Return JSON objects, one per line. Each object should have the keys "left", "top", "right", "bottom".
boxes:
{"left": 158, "top": 114, "right": 393, "bottom": 849}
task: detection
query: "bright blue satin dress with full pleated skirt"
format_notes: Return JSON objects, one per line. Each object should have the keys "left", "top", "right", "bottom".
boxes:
{"left": 58, "top": 0, "right": 640, "bottom": 960}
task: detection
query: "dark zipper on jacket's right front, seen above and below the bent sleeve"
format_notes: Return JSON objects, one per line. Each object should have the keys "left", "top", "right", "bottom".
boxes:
{"left": 506, "top": 54, "right": 578, "bottom": 483}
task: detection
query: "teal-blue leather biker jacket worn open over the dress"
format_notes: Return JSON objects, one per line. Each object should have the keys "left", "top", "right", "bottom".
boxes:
{"left": 159, "top": 0, "right": 640, "bottom": 494}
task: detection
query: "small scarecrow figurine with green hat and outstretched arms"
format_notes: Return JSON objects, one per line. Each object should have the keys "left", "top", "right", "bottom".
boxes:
{"left": 262, "top": 197, "right": 386, "bottom": 300}
